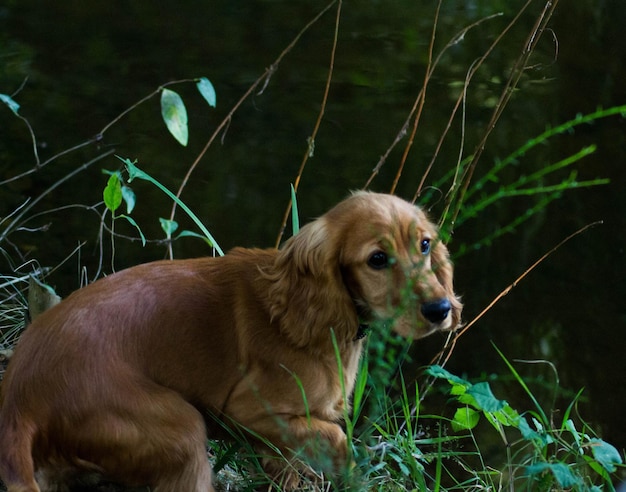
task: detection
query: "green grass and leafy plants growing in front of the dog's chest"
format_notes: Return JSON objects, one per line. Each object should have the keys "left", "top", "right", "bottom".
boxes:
{"left": 202, "top": 326, "right": 623, "bottom": 492}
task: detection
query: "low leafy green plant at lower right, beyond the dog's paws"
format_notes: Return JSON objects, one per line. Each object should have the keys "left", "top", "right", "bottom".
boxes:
{"left": 426, "top": 349, "right": 623, "bottom": 492}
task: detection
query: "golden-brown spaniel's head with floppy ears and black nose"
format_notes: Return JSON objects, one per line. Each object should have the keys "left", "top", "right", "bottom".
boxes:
{"left": 272, "top": 192, "right": 462, "bottom": 345}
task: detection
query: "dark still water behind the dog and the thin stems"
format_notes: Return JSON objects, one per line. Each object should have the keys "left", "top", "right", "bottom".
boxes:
{"left": 0, "top": 0, "right": 626, "bottom": 468}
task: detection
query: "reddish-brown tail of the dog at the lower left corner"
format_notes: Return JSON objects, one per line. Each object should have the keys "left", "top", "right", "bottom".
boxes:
{"left": 0, "top": 401, "right": 40, "bottom": 492}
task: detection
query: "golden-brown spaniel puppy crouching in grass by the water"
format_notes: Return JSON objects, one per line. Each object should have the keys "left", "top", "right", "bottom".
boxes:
{"left": 0, "top": 192, "right": 462, "bottom": 492}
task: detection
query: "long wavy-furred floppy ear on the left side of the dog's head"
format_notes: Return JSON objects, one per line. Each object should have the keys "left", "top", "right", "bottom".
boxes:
{"left": 266, "top": 217, "right": 358, "bottom": 350}
